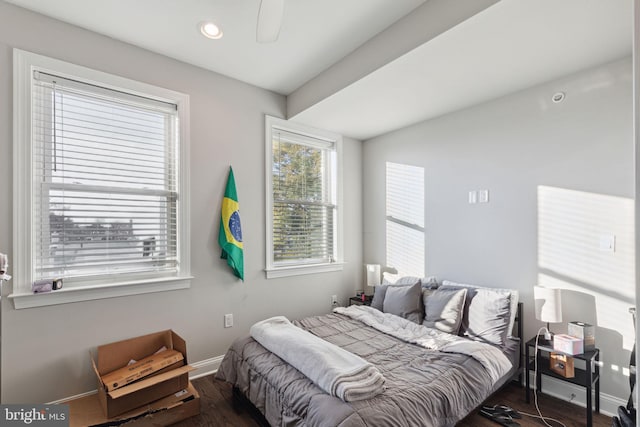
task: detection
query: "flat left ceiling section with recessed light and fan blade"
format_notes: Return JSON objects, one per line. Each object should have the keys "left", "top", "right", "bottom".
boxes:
{"left": 6, "top": 0, "right": 424, "bottom": 95}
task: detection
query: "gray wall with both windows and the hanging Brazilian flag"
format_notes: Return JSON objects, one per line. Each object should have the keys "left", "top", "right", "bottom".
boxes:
{"left": 0, "top": 2, "right": 362, "bottom": 403}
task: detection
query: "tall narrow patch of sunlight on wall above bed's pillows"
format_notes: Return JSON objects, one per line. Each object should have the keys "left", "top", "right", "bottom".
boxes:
{"left": 386, "top": 162, "right": 424, "bottom": 277}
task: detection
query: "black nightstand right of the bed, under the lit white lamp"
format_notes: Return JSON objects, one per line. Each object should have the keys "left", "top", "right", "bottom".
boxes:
{"left": 525, "top": 336, "right": 600, "bottom": 427}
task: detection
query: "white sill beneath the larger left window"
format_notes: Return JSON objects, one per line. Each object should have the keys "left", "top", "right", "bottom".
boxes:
{"left": 9, "top": 276, "right": 193, "bottom": 310}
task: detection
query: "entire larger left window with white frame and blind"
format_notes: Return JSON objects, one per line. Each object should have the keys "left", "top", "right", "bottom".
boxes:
{"left": 13, "top": 51, "right": 189, "bottom": 307}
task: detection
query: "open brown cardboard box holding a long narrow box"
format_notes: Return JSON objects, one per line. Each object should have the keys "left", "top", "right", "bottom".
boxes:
{"left": 91, "top": 330, "right": 193, "bottom": 418}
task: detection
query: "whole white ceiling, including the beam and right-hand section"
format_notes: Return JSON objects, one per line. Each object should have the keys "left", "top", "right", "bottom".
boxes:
{"left": 5, "top": 0, "right": 633, "bottom": 140}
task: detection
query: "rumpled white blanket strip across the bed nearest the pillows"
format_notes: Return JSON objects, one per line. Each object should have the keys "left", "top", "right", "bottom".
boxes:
{"left": 333, "top": 305, "right": 511, "bottom": 383}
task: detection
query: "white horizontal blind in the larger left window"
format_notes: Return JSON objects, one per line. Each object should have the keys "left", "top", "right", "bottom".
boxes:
{"left": 31, "top": 71, "right": 179, "bottom": 280}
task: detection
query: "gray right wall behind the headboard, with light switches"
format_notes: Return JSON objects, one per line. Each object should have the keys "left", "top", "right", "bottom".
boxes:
{"left": 363, "top": 59, "right": 635, "bottom": 399}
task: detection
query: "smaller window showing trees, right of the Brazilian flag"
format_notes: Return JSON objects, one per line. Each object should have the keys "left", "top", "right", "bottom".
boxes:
{"left": 266, "top": 117, "right": 342, "bottom": 277}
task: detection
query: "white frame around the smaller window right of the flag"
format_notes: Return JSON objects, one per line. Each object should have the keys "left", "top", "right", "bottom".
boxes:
{"left": 265, "top": 115, "right": 344, "bottom": 279}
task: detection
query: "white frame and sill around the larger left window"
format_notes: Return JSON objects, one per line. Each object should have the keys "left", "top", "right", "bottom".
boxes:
{"left": 9, "top": 49, "right": 192, "bottom": 309}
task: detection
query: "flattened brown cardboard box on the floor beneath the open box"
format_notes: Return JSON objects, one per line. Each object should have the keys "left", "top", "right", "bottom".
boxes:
{"left": 66, "top": 383, "right": 200, "bottom": 427}
